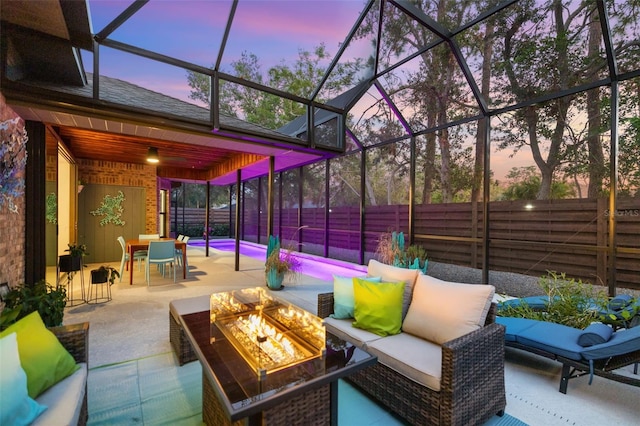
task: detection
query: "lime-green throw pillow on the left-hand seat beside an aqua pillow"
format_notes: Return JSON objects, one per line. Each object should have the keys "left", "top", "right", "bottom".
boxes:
{"left": 0, "top": 311, "right": 79, "bottom": 398}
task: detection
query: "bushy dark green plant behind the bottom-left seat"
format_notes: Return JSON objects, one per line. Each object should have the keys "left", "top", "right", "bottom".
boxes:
{"left": 2, "top": 280, "right": 67, "bottom": 328}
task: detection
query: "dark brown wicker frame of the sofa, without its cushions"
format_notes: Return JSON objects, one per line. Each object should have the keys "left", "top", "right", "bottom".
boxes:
{"left": 318, "top": 293, "right": 506, "bottom": 425}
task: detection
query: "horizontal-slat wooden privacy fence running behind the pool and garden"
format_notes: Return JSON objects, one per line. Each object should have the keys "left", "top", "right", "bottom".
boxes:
{"left": 208, "top": 199, "right": 640, "bottom": 289}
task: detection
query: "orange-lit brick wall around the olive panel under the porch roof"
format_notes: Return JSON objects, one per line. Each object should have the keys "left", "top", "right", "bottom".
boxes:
{"left": 78, "top": 159, "right": 159, "bottom": 234}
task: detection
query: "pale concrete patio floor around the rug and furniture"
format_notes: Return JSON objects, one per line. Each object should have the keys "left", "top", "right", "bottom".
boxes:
{"left": 56, "top": 246, "right": 640, "bottom": 425}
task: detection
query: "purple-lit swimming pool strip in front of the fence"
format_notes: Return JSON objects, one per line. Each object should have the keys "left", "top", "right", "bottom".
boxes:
{"left": 189, "top": 240, "right": 367, "bottom": 281}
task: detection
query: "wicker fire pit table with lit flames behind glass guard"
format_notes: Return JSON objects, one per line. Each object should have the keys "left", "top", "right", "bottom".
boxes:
{"left": 180, "top": 289, "right": 377, "bottom": 426}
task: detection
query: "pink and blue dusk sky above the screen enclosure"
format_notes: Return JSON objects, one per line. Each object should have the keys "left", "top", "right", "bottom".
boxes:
{"left": 83, "top": 0, "right": 544, "bottom": 179}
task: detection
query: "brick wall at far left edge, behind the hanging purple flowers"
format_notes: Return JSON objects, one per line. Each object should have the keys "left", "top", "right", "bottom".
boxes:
{"left": 0, "top": 94, "right": 29, "bottom": 287}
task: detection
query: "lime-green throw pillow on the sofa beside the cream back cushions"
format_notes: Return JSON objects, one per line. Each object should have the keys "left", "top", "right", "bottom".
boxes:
{"left": 353, "top": 278, "right": 405, "bottom": 336}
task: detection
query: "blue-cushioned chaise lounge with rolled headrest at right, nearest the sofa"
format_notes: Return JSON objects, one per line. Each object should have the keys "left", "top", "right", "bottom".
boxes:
{"left": 496, "top": 317, "right": 640, "bottom": 394}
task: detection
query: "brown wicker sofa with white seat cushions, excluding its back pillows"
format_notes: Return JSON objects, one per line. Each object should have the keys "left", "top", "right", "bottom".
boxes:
{"left": 318, "top": 265, "right": 506, "bottom": 425}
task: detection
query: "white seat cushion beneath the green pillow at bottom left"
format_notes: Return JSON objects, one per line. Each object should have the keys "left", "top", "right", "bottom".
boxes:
{"left": 33, "top": 362, "right": 87, "bottom": 426}
